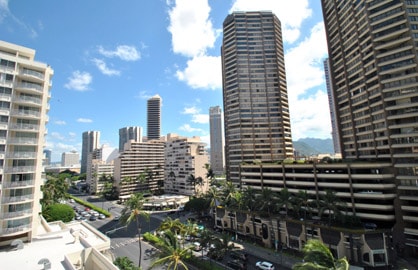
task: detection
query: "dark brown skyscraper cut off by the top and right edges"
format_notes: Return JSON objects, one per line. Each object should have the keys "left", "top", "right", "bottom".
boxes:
{"left": 322, "top": 0, "right": 418, "bottom": 255}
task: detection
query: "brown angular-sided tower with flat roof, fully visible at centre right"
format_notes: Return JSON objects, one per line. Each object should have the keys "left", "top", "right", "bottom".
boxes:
{"left": 222, "top": 12, "right": 293, "bottom": 182}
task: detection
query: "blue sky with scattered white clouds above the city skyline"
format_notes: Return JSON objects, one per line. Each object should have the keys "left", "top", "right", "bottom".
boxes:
{"left": 0, "top": 0, "right": 331, "bottom": 161}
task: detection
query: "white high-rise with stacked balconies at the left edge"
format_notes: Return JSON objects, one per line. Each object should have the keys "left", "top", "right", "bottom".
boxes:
{"left": 0, "top": 41, "right": 54, "bottom": 246}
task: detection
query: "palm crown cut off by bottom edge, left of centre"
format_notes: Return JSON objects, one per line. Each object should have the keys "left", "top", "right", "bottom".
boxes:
{"left": 150, "top": 231, "right": 191, "bottom": 270}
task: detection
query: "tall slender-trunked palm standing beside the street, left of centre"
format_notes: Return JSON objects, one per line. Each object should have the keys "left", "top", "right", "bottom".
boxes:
{"left": 120, "top": 193, "right": 149, "bottom": 267}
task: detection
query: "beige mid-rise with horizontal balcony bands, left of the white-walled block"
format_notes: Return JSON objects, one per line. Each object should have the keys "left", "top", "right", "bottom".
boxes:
{"left": 114, "top": 140, "right": 164, "bottom": 200}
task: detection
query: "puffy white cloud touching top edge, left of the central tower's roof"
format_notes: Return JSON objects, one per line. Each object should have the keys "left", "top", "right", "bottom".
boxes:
{"left": 168, "top": 0, "right": 220, "bottom": 57}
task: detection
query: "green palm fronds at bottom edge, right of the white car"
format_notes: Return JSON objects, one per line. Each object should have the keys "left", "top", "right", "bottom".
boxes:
{"left": 292, "top": 239, "right": 350, "bottom": 270}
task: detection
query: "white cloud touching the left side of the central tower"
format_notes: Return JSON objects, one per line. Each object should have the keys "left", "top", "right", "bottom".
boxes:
{"left": 176, "top": 55, "right": 222, "bottom": 90}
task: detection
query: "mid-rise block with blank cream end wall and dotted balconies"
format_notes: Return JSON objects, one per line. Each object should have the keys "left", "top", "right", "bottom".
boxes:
{"left": 164, "top": 134, "right": 209, "bottom": 196}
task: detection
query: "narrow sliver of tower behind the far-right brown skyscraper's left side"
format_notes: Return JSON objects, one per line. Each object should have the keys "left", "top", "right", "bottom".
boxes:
{"left": 324, "top": 58, "right": 341, "bottom": 153}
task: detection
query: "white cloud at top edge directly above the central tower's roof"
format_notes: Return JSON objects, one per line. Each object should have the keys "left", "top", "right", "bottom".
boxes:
{"left": 229, "top": 0, "right": 312, "bottom": 43}
